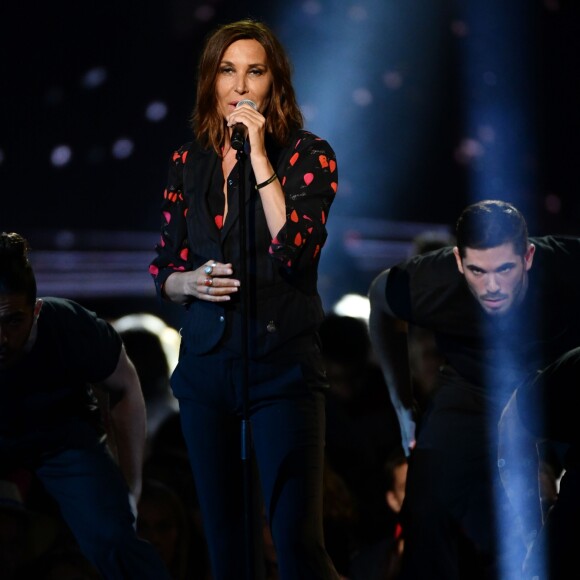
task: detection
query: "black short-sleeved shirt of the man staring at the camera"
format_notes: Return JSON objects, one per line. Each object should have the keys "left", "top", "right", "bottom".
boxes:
{"left": 386, "top": 236, "right": 580, "bottom": 405}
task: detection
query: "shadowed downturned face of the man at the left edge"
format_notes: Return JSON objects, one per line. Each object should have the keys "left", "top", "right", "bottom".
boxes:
{"left": 0, "top": 294, "right": 40, "bottom": 369}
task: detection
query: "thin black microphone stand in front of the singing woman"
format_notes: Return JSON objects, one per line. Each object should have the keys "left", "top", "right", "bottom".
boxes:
{"left": 232, "top": 141, "right": 254, "bottom": 580}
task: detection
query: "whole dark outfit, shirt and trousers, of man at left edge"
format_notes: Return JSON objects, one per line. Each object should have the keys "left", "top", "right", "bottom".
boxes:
{"left": 0, "top": 298, "right": 169, "bottom": 580}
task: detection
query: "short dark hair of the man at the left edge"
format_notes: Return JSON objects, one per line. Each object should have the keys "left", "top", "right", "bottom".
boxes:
{"left": 0, "top": 232, "right": 36, "bottom": 305}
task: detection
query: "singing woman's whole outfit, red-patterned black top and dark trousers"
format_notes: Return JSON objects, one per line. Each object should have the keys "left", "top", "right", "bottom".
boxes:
{"left": 150, "top": 130, "right": 337, "bottom": 580}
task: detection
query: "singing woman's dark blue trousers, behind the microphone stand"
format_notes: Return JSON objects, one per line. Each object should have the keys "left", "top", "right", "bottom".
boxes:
{"left": 172, "top": 354, "right": 338, "bottom": 580}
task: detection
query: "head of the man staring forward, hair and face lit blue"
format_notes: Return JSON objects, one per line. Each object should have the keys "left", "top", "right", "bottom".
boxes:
{"left": 453, "top": 200, "right": 535, "bottom": 316}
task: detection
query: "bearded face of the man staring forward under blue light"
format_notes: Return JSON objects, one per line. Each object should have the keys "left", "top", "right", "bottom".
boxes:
{"left": 453, "top": 243, "right": 536, "bottom": 316}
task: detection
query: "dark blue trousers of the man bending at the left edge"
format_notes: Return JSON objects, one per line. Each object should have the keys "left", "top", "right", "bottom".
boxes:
{"left": 36, "top": 444, "right": 170, "bottom": 580}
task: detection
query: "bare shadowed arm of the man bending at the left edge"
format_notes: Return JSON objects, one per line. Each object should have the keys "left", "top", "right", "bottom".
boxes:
{"left": 97, "top": 346, "right": 147, "bottom": 502}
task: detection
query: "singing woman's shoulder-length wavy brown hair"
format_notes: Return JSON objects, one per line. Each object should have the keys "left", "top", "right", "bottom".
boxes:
{"left": 191, "top": 19, "right": 304, "bottom": 155}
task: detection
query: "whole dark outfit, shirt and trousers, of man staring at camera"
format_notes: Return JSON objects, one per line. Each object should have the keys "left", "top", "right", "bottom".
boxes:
{"left": 386, "top": 236, "right": 580, "bottom": 580}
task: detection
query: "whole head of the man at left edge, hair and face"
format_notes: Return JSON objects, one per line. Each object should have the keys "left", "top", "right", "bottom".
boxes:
{"left": 0, "top": 232, "right": 42, "bottom": 369}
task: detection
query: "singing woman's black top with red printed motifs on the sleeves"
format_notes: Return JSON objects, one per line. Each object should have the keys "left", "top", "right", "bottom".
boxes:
{"left": 150, "top": 130, "right": 337, "bottom": 358}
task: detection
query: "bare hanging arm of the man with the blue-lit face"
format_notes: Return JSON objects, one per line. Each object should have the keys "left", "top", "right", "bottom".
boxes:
{"left": 369, "top": 270, "right": 415, "bottom": 456}
